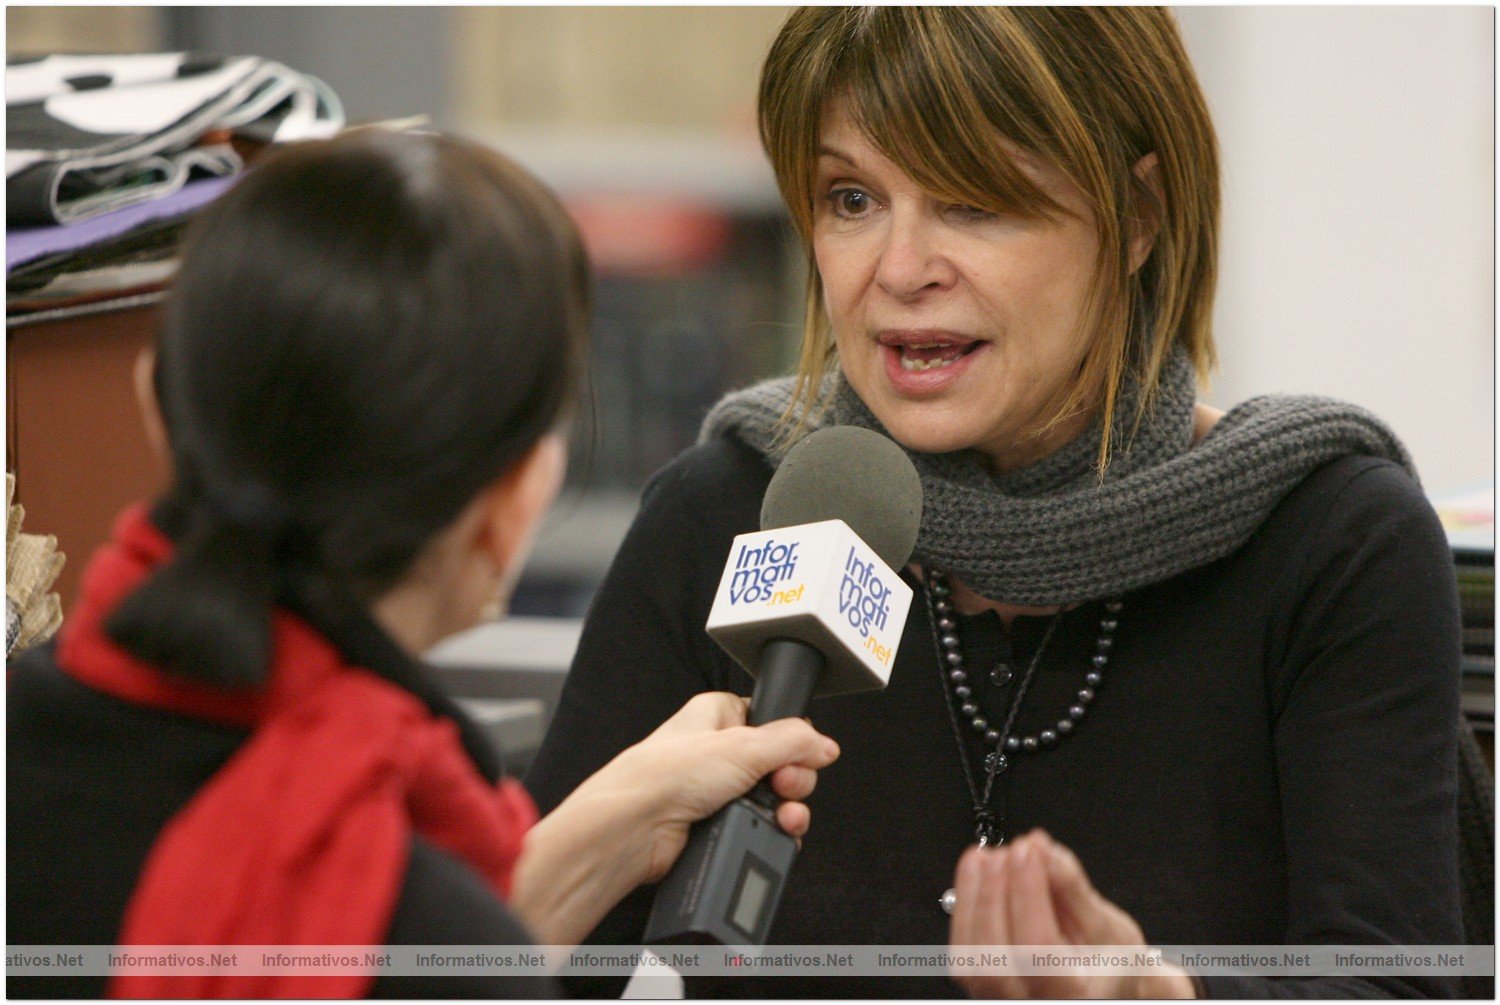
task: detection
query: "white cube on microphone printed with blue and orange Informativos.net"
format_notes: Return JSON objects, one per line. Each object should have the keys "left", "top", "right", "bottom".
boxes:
{"left": 708, "top": 521, "right": 912, "bottom": 698}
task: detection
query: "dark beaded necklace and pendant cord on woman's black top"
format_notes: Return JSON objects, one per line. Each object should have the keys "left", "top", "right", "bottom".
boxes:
{"left": 923, "top": 569, "right": 1124, "bottom": 914}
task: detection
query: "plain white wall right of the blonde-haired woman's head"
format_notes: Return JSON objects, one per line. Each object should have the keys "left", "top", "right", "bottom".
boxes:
{"left": 1176, "top": 8, "right": 1496, "bottom": 492}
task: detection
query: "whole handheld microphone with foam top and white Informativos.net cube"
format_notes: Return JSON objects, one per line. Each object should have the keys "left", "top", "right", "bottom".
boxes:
{"left": 645, "top": 426, "right": 923, "bottom": 950}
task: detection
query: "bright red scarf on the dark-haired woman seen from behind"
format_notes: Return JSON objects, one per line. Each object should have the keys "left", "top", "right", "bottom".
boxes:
{"left": 57, "top": 507, "right": 537, "bottom": 998}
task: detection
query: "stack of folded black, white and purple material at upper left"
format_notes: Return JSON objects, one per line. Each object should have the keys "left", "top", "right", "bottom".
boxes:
{"left": 5, "top": 53, "right": 344, "bottom": 326}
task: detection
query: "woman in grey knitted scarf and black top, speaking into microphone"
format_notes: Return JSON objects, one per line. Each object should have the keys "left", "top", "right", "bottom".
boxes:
{"left": 528, "top": 8, "right": 1461, "bottom": 998}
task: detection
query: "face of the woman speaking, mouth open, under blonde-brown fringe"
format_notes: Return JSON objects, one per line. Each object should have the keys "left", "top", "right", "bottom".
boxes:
{"left": 813, "top": 102, "right": 1098, "bottom": 470}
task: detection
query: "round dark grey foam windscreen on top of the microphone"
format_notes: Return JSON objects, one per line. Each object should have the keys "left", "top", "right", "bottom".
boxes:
{"left": 761, "top": 426, "right": 923, "bottom": 570}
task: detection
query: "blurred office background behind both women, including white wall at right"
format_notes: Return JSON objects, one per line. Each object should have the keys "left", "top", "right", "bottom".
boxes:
{"left": 6, "top": 6, "right": 1494, "bottom": 617}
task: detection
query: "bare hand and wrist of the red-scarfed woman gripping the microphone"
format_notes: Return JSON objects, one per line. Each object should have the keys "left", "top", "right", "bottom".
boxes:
{"left": 510, "top": 692, "right": 839, "bottom": 945}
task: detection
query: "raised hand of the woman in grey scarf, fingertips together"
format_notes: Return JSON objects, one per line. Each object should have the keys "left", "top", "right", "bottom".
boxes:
{"left": 951, "top": 831, "right": 1194, "bottom": 998}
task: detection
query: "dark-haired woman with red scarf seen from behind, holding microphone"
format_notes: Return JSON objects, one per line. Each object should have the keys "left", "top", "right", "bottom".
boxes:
{"left": 8, "top": 131, "right": 837, "bottom": 998}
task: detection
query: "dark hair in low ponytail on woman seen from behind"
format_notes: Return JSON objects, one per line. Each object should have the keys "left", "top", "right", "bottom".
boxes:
{"left": 108, "top": 131, "right": 588, "bottom": 686}
